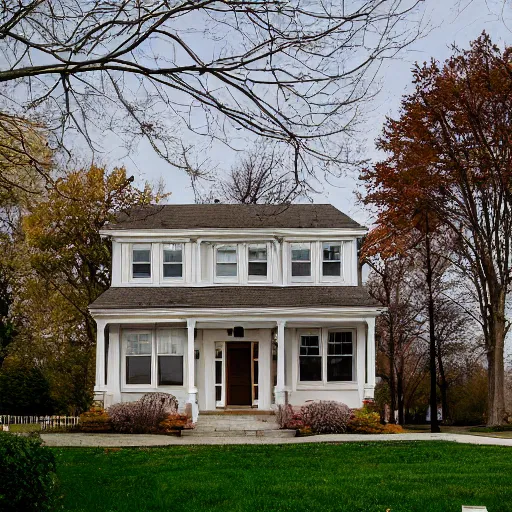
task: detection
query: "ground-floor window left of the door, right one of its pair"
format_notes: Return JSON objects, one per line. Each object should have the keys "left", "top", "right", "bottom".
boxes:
{"left": 157, "top": 329, "right": 186, "bottom": 386}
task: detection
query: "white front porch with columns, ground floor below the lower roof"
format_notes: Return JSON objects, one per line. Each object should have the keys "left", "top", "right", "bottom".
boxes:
{"left": 95, "top": 310, "right": 378, "bottom": 421}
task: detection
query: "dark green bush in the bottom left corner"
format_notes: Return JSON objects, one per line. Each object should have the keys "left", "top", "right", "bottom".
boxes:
{"left": 0, "top": 432, "right": 56, "bottom": 512}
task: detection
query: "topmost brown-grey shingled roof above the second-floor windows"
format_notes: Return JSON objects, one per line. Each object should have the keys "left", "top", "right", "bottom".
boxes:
{"left": 104, "top": 204, "right": 363, "bottom": 230}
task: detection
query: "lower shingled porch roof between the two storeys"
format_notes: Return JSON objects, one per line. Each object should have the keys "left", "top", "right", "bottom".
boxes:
{"left": 89, "top": 286, "right": 380, "bottom": 310}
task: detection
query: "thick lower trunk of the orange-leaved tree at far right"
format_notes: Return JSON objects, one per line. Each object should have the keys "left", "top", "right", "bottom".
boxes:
{"left": 487, "top": 314, "right": 506, "bottom": 426}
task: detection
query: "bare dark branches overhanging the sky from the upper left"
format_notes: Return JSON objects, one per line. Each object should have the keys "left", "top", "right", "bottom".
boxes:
{"left": 0, "top": 0, "right": 422, "bottom": 181}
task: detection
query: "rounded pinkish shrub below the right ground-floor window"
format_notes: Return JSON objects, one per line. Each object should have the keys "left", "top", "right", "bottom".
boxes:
{"left": 301, "top": 400, "right": 350, "bottom": 434}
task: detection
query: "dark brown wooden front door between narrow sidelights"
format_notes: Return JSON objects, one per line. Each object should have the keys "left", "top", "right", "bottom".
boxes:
{"left": 226, "top": 342, "right": 252, "bottom": 405}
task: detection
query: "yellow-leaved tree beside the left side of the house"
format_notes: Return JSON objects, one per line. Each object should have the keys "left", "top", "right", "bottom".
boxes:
{"left": 9, "top": 166, "right": 165, "bottom": 412}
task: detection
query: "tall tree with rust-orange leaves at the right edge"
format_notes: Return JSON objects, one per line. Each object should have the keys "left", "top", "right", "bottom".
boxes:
{"left": 362, "top": 33, "right": 512, "bottom": 425}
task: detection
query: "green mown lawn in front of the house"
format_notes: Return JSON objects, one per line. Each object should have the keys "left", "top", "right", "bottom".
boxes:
{"left": 53, "top": 441, "right": 512, "bottom": 512}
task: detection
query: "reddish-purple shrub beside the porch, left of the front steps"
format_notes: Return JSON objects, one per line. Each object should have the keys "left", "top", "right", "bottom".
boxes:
{"left": 107, "top": 393, "right": 178, "bottom": 434}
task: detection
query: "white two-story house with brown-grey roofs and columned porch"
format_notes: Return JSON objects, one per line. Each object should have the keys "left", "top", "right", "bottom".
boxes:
{"left": 90, "top": 204, "right": 380, "bottom": 420}
